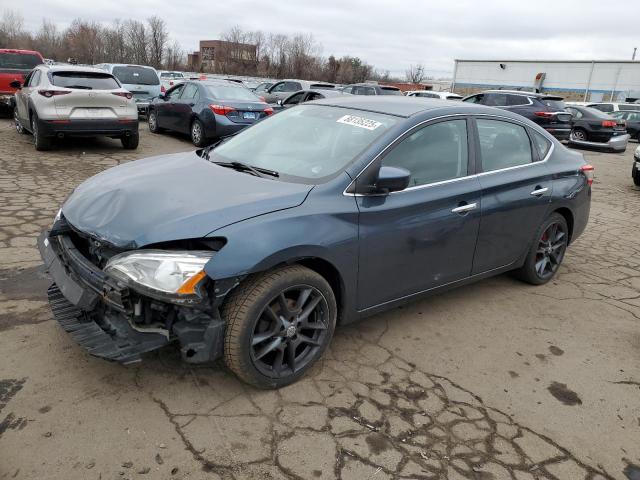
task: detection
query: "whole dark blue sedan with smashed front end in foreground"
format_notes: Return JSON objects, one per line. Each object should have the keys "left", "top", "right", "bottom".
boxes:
{"left": 39, "top": 96, "right": 593, "bottom": 388}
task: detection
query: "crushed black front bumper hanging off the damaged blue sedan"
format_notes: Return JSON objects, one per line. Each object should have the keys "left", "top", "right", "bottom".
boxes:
{"left": 38, "top": 232, "right": 169, "bottom": 364}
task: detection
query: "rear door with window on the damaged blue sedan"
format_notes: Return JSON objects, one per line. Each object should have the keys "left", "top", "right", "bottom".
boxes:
{"left": 473, "top": 116, "right": 553, "bottom": 274}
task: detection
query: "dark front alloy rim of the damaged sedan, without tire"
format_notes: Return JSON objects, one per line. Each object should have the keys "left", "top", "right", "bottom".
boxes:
{"left": 251, "top": 285, "right": 329, "bottom": 378}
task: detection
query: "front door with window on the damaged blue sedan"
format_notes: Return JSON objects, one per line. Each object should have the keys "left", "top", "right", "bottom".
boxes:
{"left": 356, "top": 118, "right": 481, "bottom": 310}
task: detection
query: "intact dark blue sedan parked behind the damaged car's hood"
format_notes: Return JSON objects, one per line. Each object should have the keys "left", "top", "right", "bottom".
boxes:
{"left": 147, "top": 80, "right": 273, "bottom": 147}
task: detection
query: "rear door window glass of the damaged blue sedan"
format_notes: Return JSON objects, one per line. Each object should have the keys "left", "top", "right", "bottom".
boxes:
{"left": 477, "top": 119, "right": 533, "bottom": 172}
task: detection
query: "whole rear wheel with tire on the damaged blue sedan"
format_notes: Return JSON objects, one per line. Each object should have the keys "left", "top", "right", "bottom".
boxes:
{"left": 514, "top": 212, "right": 569, "bottom": 285}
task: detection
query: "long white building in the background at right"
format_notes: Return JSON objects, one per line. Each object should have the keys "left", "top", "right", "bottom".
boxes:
{"left": 452, "top": 60, "right": 640, "bottom": 102}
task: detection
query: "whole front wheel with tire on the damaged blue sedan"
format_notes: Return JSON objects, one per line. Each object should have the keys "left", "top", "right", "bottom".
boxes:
{"left": 222, "top": 265, "right": 337, "bottom": 388}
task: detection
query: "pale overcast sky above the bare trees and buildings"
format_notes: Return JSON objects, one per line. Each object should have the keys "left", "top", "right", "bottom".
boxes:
{"left": 10, "top": 0, "right": 640, "bottom": 76}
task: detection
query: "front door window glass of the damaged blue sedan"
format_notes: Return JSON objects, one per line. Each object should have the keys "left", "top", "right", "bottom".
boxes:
{"left": 382, "top": 120, "right": 468, "bottom": 187}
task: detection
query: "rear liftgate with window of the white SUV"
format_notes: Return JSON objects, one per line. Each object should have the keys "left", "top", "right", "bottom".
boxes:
{"left": 50, "top": 71, "right": 127, "bottom": 120}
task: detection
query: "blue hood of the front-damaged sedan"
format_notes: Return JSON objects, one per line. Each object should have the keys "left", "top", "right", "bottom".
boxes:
{"left": 62, "top": 152, "right": 313, "bottom": 249}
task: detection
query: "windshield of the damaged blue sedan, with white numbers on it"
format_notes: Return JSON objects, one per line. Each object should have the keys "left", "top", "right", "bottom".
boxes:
{"left": 212, "top": 105, "right": 397, "bottom": 183}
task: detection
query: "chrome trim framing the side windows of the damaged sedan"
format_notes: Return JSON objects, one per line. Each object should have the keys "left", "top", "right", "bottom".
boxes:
{"left": 342, "top": 113, "right": 556, "bottom": 197}
